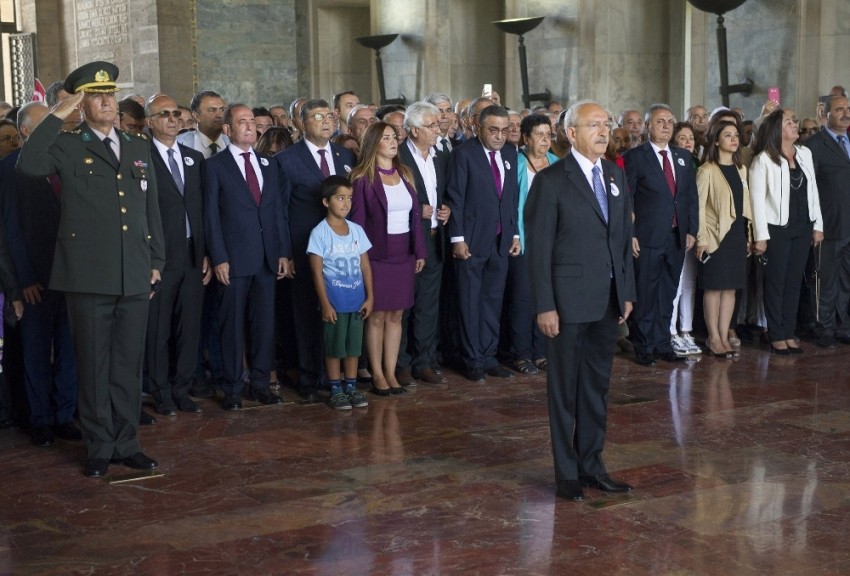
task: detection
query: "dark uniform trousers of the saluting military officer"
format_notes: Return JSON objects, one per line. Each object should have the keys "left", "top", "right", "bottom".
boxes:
{"left": 65, "top": 292, "right": 149, "bottom": 459}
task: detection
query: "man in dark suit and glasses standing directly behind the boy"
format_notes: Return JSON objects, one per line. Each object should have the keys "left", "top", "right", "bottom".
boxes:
{"left": 275, "top": 100, "right": 354, "bottom": 399}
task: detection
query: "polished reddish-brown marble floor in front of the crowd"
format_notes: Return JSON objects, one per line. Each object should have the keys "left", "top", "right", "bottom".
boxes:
{"left": 0, "top": 345, "right": 850, "bottom": 576}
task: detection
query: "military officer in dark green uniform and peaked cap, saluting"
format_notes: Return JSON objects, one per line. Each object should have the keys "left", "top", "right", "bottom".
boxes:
{"left": 17, "top": 62, "right": 165, "bottom": 477}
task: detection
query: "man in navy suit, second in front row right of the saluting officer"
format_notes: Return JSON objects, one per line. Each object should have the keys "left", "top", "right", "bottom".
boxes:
{"left": 203, "top": 104, "right": 294, "bottom": 410}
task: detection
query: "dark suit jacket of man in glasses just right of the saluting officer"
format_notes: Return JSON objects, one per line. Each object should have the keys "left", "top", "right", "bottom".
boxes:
{"left": 151, "top": 142, "right": 205, "bottom": 270}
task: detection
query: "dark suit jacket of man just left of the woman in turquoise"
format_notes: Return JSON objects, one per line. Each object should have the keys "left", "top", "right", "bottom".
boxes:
{"left": 446, "top": 138, "right": 519, "bottom": 256}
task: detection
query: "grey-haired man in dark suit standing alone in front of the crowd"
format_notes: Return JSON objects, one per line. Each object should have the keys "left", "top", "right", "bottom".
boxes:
{"left": 524, "top": 101, "right": 635, "bottom": 500}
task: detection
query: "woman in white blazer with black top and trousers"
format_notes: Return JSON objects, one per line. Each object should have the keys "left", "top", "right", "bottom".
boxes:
{"left": 750, "top": 109, "right": 823, "bottom": 356}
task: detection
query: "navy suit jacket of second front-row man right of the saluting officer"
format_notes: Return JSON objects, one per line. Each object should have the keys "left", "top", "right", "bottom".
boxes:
{"left": 203, "top": 150, "right": 292, "bottom": 276}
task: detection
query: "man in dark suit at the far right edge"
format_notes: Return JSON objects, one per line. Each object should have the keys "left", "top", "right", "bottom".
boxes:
{"left": 805, "top": 96, "right": 850, "bottom": 348}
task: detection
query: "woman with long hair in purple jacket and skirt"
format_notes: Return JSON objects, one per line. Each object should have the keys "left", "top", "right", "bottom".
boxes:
{"left": 349, "top": 122, "right": 426, "bottom": 396}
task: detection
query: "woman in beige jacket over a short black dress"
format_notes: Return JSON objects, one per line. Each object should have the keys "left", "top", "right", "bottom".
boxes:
{"left": 696, "top": 120, "right": 751, "bottom": 358}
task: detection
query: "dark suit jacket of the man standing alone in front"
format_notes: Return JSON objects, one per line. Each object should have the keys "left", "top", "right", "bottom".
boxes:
{"left": 523, "top": 154, "right": 636, "bottom": 323}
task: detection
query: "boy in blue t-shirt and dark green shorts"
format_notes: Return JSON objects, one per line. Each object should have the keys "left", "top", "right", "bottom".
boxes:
{"left": 307, "top": 176, "right": 372, "bottom": 410}
